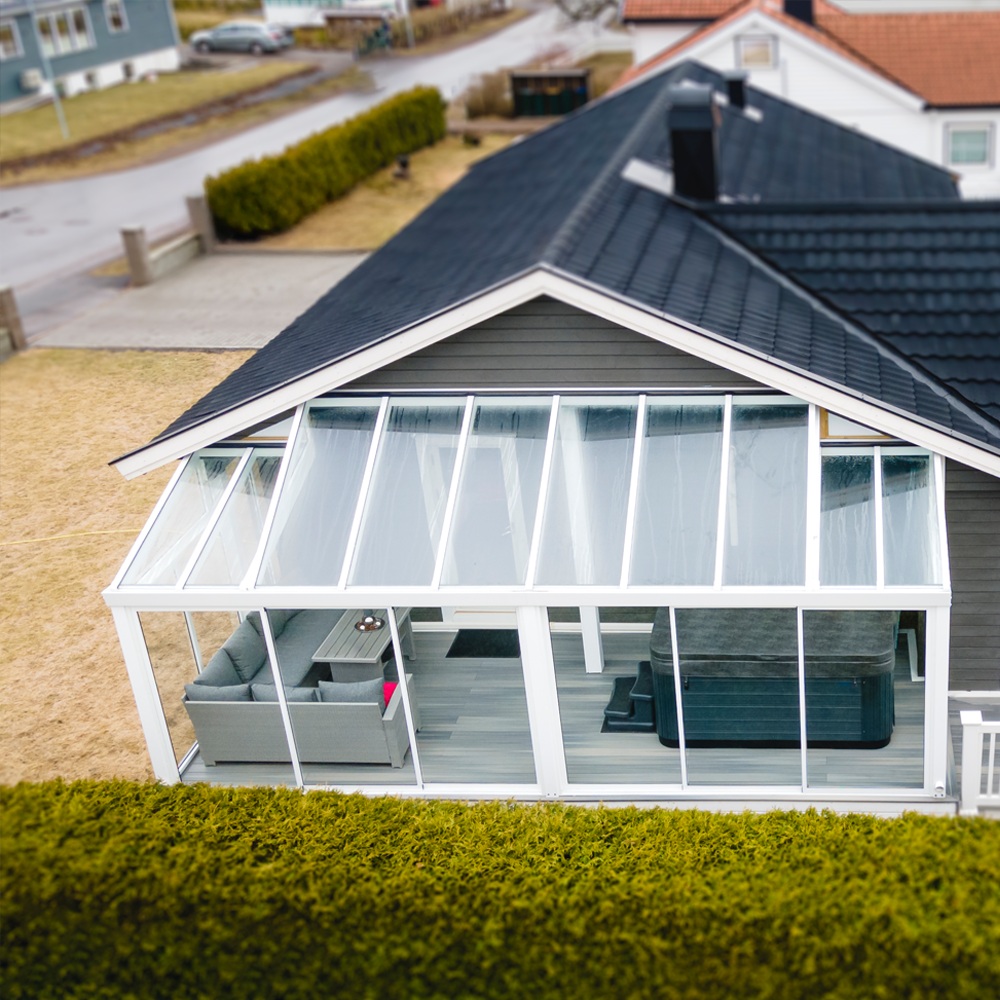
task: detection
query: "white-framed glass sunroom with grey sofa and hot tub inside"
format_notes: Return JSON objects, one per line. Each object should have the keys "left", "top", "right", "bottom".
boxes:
{"left": 105, "top": 391, "right": 950, "bottom": 805}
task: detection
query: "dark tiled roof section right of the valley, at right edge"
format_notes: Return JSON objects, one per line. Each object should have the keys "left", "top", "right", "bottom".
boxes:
{"left": 712, "top": 202, "right": 1000, "bottom": 420}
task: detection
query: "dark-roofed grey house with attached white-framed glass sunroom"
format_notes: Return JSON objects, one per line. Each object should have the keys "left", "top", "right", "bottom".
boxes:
{"left": 104, "top": 63, "right": 1000, "bottom": 813}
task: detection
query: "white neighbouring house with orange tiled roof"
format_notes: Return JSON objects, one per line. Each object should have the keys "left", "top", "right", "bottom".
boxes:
{"left": 623, "top": 0, "right": 1000, "bottom": 197}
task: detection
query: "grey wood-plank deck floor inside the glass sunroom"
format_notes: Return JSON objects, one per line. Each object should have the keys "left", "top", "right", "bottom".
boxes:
{"left": 184, "top": 632, "right": 924, "bottom": 788}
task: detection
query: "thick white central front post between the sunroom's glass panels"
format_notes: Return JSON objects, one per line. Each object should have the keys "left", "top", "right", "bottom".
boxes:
{"left": 517, "top": 607, "right": 568, "bottom": 798}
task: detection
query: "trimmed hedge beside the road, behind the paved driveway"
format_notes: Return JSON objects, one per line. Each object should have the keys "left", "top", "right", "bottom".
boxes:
{"left": 205, "top": 87, "right": 445, "bottom": 239}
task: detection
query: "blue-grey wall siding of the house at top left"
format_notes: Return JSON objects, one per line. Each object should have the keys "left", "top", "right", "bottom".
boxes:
{"left": 0, "top": 0, "right": 179, "bottom": 101}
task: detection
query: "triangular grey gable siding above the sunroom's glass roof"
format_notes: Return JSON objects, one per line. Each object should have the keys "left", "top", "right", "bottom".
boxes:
{"left": 350, "top": 298, "right": 761, "bottom": 389}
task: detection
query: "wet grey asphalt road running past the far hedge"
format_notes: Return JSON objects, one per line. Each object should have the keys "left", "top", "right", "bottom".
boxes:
{"left": 0, "top": 9, "right": 579, "bottom": 293}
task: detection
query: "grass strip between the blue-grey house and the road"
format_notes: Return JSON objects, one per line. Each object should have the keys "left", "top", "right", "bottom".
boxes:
{"left": 0, "top": 60, "right": 303, "bottom": 162}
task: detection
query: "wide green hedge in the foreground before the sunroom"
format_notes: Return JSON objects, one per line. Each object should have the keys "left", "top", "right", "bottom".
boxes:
{"left": 0, "top": 782, "right": 1000, "bottom": 1000}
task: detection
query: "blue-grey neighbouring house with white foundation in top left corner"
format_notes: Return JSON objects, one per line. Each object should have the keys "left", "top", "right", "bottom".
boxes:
{"left": 0, "top": 0, "right": 180, "bottom": 104}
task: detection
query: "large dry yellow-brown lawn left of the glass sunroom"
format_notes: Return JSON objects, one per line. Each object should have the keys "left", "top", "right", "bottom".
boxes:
{"left": 0, "top": 350, "right": 250, "bottom": 783}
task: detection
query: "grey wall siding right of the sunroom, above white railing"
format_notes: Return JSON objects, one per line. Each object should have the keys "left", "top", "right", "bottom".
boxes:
{"left": 945, "top": 461, "right": 1000, "bottom": 691}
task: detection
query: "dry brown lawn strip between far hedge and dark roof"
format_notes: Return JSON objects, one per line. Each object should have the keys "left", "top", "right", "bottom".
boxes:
{"left": 256, "top": 135, "right": 513, "bottom": 250}
